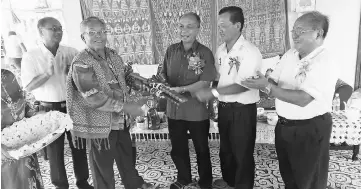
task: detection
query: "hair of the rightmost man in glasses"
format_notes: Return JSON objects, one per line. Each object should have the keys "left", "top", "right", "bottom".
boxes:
{"left": 299, "top": 11, "right": 330, "bottom": 39}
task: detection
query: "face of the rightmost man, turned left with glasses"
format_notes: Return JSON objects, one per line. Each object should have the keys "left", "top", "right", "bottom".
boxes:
{"left": 292, "top": 19, "right": 317, "bottom": 56}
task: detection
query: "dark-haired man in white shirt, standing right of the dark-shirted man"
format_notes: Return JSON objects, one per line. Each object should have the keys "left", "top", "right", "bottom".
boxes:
{"left": 196, "top": 6, "right": 262, "bottom": 189}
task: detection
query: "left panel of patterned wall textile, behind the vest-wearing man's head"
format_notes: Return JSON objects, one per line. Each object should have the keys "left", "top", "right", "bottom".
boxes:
{"left": 81, "top": 0, "right": 154, "bottom": 64}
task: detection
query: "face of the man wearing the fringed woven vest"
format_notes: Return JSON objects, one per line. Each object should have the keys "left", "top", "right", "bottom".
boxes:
{"left": 82, "top": 21, "right": 107, "bottom": 50}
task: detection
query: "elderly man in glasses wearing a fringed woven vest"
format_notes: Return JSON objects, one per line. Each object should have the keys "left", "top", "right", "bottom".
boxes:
{"left": 66, "top": 17, "right": 153, "bottom": 189}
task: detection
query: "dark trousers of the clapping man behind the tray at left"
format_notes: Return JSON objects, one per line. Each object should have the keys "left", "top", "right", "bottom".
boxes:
{"left": 39, "top": 103, "right": 89, "bottom": 189}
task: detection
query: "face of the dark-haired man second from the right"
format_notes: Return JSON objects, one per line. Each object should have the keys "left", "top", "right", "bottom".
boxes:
{"left": 217, "top": 12, "right": 242, "bottom": 43}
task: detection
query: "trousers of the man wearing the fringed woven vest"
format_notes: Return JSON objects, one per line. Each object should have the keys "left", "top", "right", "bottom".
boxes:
{"left": 89, "top": 130, "right": 144, "bottom": 189}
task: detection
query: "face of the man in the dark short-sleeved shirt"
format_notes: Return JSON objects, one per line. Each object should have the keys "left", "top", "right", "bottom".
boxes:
{"left": 178, "top": 15, "right": 199, "bottom": 43}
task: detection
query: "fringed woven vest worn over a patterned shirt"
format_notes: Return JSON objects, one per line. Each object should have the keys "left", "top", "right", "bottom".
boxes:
{"left": 66, "top": 48, "right": 127, "bottom": 147}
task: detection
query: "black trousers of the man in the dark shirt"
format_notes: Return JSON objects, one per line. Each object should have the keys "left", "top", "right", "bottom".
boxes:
{"left": 168, "top": 118, "right": 212, "bottom": 188}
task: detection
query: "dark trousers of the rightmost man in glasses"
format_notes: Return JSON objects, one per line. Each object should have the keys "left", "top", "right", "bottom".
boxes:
{"left": 275, "top": 113, "right": 332, "bottom": 189}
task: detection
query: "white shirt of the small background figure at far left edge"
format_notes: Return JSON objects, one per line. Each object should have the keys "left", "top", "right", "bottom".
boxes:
{"left": 5, "top": 35, "right": 23, "bottom": 58}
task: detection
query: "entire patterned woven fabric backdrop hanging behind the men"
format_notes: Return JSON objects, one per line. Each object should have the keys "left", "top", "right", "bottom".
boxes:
{"left": 80, "top": 0, "right": 286, "bottom": 64}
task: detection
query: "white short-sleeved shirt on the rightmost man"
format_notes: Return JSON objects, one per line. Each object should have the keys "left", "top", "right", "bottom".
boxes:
{"left": 270, "top": 46, "right": 339, "bottom": 120}
